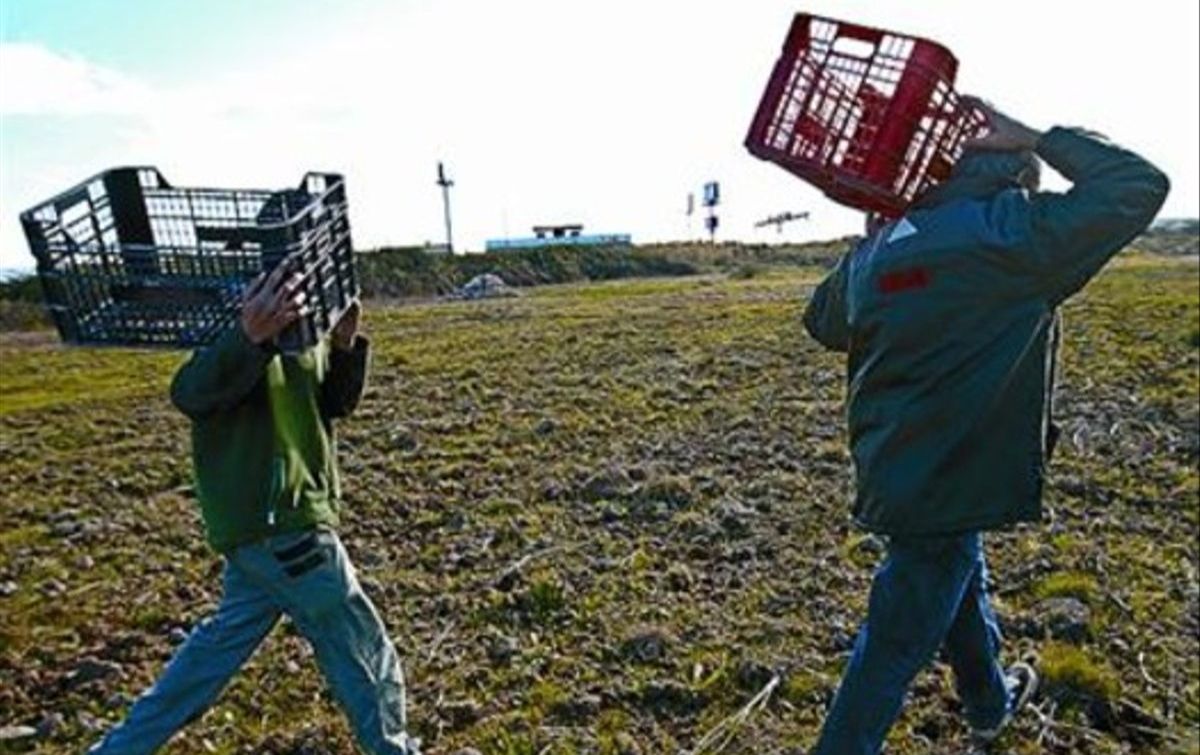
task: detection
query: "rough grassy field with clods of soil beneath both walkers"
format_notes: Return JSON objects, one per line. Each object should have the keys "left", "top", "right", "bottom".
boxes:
{"left": 0, "top": 256, "right": 1200, "bottom": 755}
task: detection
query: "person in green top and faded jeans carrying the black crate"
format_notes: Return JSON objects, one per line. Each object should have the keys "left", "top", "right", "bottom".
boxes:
{"left": 90, "top": 264, "right": 418, "bottom": 755}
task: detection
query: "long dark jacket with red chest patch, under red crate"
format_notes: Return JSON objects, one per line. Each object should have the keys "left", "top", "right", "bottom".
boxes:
{"left": 804, "top": 128, "right": 1169, "bottom": 535}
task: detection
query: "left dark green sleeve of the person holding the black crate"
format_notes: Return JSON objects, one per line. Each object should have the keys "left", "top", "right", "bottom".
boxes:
{"left": 170, "top": 325, "right": 275, "bottom": 419}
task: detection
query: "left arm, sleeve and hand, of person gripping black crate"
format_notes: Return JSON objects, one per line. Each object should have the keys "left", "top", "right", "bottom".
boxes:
{"left": 170, "top": 264, "right": 304, "bottom": 419}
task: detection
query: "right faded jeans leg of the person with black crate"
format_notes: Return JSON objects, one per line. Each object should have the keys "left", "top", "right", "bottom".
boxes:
{"left": 230, "top": 531, "right": 416, "bottom": 755}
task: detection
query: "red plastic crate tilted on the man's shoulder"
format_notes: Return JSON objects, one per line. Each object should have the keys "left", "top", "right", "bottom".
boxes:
{"left": 745, "top": 13, "right": 986, "bottom": 217}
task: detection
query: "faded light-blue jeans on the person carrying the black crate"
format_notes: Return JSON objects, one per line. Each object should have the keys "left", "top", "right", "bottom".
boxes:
{"left": 89, "top": 529, "right": 416, "bottom": 755}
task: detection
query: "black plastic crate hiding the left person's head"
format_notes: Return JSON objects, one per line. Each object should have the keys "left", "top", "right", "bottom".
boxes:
{"left": 20, "top": 167, "right": 359, "bottom": 353}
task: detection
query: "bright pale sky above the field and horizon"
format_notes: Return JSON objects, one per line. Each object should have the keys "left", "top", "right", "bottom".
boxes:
{"left": 0, "top": 0, "right": 1200, "bottom": 268}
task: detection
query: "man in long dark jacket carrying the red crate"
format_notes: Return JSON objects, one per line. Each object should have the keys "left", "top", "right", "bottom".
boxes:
{"left": 804, "top": 102, "right": 1169, "bottom": 755}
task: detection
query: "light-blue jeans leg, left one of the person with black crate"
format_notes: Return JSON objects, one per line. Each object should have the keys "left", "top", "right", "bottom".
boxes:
{"left": 89, "top": 564, "right": 280, "bottom": 755}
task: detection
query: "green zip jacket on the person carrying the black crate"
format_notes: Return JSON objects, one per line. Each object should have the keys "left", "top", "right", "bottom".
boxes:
{"left": 170, "top": 326, "right": 370, "bottom": 552}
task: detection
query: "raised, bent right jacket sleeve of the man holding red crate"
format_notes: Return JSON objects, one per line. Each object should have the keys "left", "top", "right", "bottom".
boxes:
{"left": 1028, "top": 128, "right": 1170, "bottom": 305}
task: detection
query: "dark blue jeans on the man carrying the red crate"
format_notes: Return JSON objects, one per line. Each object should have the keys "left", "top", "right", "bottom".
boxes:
{"left": 811, "top": 533, "right": 1012, "bottom": 755}
